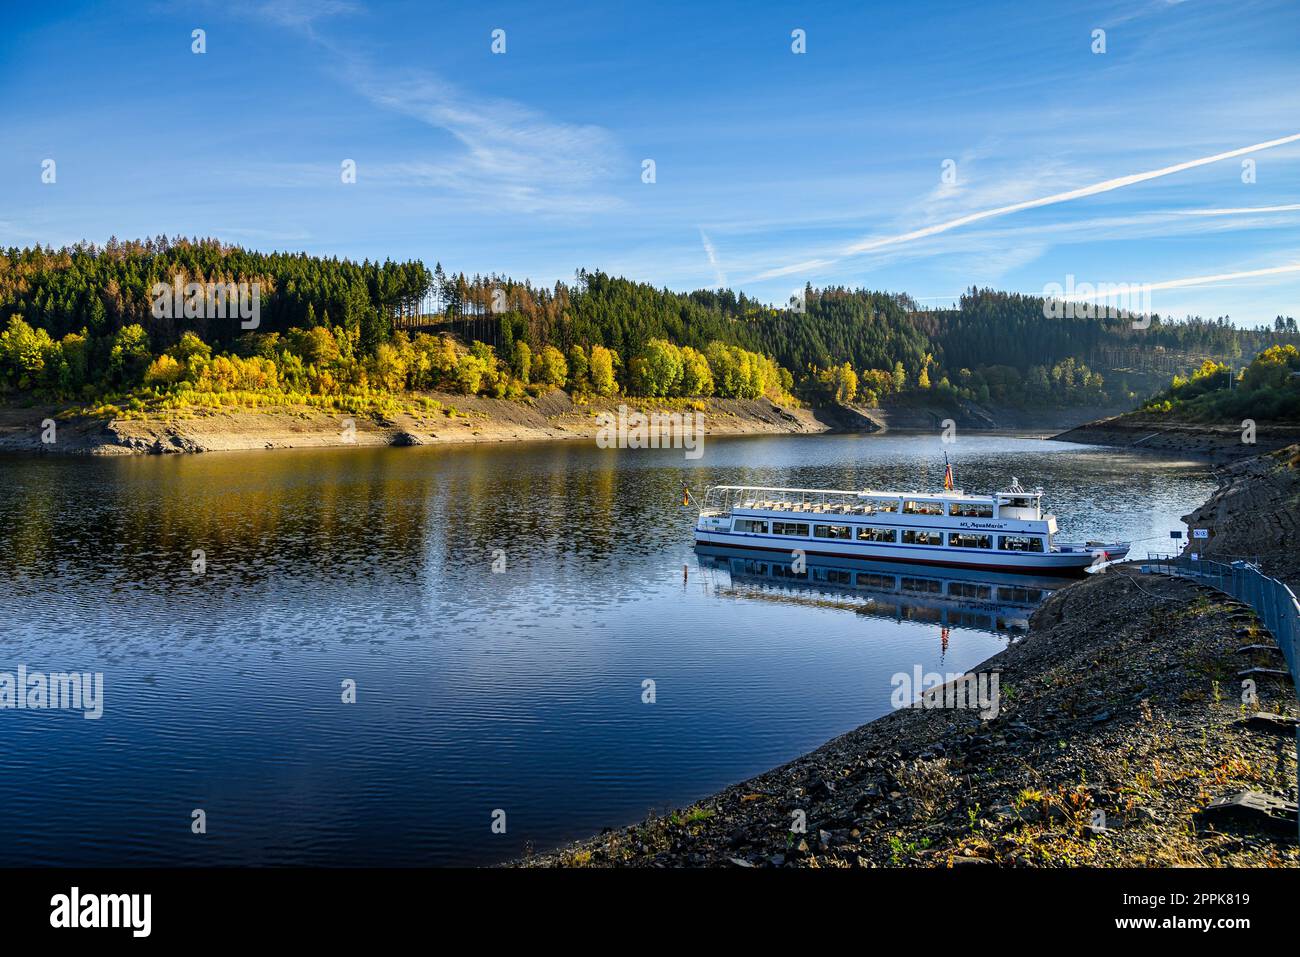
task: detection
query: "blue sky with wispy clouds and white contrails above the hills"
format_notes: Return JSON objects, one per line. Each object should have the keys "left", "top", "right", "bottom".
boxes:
{"left": 0, "top": 0, "right": 1300, "bottom": 325}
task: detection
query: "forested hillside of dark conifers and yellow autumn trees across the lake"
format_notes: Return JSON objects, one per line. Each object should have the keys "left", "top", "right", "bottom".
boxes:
{"left": 0, "top": 237, "right": 1300, "bottom": 411}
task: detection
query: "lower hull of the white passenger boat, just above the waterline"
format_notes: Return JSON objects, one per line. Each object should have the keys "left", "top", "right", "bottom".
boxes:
{"left": 696, "top": 527, "right": 1128, "bottom": 575}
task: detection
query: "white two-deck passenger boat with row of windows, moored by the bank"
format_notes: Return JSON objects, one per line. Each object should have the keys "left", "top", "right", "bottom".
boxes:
{"left": 696, "top": 472, "right": 1128, "bottom": 575}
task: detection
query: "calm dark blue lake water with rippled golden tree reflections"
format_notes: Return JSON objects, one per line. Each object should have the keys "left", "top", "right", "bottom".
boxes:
{"left": 0, "top": 436, "right": 1214, "bottom": 866}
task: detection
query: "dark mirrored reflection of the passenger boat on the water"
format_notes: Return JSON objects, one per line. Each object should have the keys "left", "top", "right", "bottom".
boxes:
{"left": 696, "top": 545, "right": 1069, "bottom": 635}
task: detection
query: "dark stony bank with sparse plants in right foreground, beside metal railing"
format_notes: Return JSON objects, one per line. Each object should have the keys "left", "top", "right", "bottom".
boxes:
{"left": 516, "top": 447, "right": 1300, "bottom": 867}
